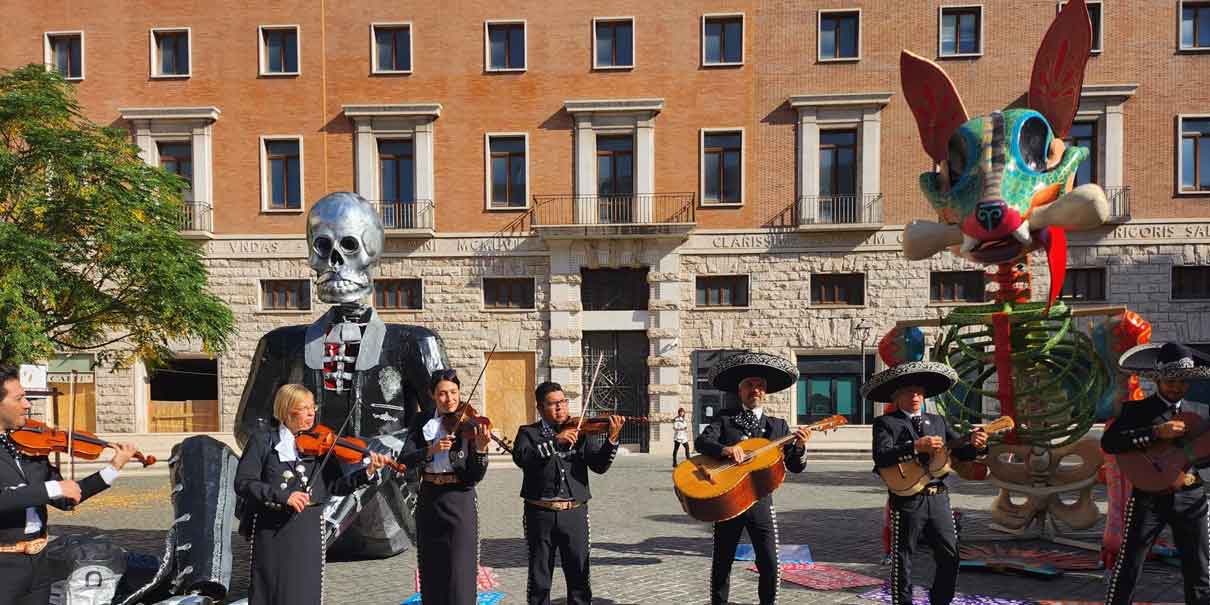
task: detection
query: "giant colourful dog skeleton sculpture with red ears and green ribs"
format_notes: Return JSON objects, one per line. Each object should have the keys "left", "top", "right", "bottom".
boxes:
{"left": 885, "top": 0, "right": 1150, "bottom": 537}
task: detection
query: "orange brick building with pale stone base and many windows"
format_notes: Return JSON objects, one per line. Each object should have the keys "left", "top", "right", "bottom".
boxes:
{"left": 0, "top": 0, "right": 1210, "bottom": 449}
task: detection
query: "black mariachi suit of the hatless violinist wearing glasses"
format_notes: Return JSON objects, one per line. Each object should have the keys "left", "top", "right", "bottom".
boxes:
{"left": 513, "top": 420, "right": 617, "bottom": 605}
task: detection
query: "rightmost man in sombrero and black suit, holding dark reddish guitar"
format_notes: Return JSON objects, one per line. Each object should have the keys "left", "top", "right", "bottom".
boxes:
{"left": 1101, "top": 342, "right": 1210, "bottom": 605}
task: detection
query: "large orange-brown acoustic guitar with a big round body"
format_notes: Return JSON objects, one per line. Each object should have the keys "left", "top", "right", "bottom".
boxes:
{"left": 673, "top": 415, "right": 848, "bottom": 522}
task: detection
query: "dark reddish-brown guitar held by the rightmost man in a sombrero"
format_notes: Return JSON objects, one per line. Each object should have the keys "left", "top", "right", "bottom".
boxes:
{"left": 1114, "top": 411, "right": 1210, "bottom": 492}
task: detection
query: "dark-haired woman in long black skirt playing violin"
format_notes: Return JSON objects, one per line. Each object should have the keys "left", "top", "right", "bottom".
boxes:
{"left": 399, "top": 369, "right": 490, "bottom": 605}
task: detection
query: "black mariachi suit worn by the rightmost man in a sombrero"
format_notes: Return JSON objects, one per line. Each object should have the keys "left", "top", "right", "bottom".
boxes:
{"left": 1101, "top": 394, "right": 1210, "bottom": 605}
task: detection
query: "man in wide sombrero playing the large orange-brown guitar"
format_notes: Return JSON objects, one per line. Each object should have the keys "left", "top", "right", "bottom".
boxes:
{"left": 693, "top": 353, "right": 811, "bottom": 605}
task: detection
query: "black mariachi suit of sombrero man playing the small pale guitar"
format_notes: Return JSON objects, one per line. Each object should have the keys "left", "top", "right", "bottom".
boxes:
{"left": 874, "top": 410, "right": 979, "bottom": 605}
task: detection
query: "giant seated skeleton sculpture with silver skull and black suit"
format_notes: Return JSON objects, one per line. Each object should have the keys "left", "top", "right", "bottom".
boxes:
{"left": 123, "top": 192, "right": 448, "bottom": 605}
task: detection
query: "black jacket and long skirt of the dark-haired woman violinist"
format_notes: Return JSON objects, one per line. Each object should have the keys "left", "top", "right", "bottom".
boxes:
{"left": 399, "top": 414, "right": 488, "bottom": 605}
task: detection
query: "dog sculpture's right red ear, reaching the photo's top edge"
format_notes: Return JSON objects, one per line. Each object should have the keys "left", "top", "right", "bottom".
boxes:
{"left": 1029, "top": 0, "right": 1093, "bottom": 139}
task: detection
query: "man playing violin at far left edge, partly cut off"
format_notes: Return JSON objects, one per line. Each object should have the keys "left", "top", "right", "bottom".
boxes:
{"left": 0, "top": 364, "right": 138, "bottom": 605}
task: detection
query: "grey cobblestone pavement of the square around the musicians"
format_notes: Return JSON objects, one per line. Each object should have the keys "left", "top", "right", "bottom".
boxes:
{"left": 51, "top": 455, "right": 1182, "bottom": 605}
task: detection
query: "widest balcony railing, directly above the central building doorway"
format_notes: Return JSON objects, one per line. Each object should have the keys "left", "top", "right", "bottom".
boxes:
{"left": 532, "top": 194, "right": 696, "bottom": 227}
